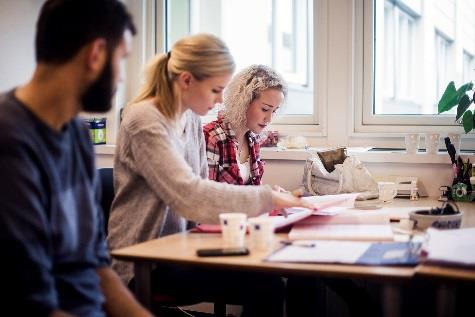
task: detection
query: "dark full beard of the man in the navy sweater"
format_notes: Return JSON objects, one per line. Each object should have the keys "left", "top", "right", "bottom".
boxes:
{"left": 81, "top": 58, "right": 115, "bottom": 112}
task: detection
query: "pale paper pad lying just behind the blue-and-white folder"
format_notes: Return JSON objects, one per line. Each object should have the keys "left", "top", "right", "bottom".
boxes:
{"left": 289, "top": 223, "right": 394, "bottom": 241}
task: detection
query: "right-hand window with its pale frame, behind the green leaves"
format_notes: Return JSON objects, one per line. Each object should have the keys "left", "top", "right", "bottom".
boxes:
{"left": 354, "top": 0, "right": 475, "bottom": 133}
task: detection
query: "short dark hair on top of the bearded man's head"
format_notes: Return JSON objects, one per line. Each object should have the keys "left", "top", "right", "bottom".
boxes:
{"left": 35, "top": 0, "right": 136, "bottom": 64}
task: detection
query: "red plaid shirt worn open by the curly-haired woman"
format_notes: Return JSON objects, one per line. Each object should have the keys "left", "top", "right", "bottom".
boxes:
{"left": 203, "top": 117, "right": 264, "bottom": 185}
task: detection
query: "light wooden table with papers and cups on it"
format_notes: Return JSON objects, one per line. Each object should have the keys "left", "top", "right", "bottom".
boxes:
{"left": 111, "top": 199, "right": 475, "bottom": 316}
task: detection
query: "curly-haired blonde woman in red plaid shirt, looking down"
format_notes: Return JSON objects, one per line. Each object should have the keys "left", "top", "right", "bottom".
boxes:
{"left": 203, "top": 65, "right": 287, "bottom": 185}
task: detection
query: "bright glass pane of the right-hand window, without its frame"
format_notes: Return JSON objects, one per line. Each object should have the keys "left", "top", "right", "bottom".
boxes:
{"left": 373, "top": 0, "right": 475, "bottom": 115}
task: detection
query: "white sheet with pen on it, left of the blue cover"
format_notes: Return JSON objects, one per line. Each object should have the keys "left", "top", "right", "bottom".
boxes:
{"left": 266, "top": 240, "right": 371, "bottom": 264}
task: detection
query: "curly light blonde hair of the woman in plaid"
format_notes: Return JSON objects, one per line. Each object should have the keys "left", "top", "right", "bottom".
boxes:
{"left": 222, "top": 65, "right": 287, "bottom": 129}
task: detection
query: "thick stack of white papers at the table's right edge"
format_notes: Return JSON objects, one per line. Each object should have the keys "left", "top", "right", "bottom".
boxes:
{"left": 423, "top": 228, "right": 475, "bottom": 266}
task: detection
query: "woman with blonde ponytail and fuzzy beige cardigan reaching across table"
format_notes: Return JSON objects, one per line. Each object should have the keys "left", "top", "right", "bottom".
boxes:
{"left": 108, "top": 34, "right": 311, "bottom": 314}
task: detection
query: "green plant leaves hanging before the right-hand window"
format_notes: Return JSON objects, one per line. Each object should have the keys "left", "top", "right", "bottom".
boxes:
{"left": 438, "top": 81, "right": 475, "bottom": 133}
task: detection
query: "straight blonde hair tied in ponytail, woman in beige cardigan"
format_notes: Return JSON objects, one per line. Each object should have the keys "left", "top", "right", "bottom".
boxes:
{"left": 133, "top": 34, "right": 236, "bottom": 119}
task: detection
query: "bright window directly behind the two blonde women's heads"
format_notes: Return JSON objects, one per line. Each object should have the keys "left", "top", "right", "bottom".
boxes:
{"left": 166, "top": 0, "right": 316, "bottom": 124}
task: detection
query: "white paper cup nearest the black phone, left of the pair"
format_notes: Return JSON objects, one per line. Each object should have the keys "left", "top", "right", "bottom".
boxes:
{"left": 219, "top": 213, "right": 247, "bottom": 248}
